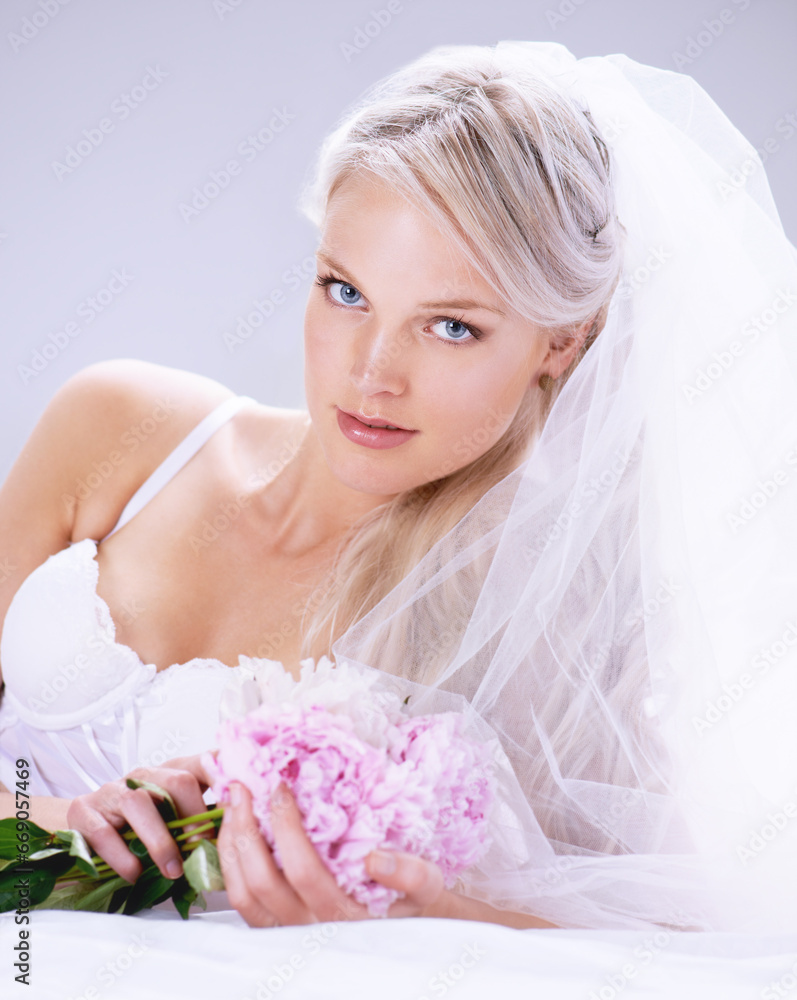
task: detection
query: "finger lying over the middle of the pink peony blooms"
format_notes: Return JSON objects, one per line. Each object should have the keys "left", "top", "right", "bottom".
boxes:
{"left": 271, "top": 784, "right": 368, "bottom": 921}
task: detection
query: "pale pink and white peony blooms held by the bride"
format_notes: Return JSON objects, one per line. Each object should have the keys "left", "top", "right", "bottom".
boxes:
{"left": 203, "top": 657, "right": 494, "bottom": 917}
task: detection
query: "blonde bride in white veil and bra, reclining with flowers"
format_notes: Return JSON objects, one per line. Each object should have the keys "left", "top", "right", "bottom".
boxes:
{"left": 0, "top": 37, "right": 797, "bottom": 927}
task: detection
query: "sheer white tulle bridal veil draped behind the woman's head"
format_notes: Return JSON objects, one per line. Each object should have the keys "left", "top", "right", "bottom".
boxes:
{"left": 318, "top": 42, "right": 797, "bottom": 930}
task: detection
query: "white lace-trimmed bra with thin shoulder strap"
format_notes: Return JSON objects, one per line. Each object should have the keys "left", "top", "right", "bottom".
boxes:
{"left": 0, "top": 396, "right": 254, "bottom": 798}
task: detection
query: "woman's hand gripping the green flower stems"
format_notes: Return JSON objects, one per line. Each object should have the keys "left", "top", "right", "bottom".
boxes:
{"left": 67, "top": 754, "right": 209, "bottom": 882}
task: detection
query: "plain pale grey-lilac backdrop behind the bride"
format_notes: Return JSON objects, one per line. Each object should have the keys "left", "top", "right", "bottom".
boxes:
{"left": 0, "top": 0, "right": 797, "bottom": 478}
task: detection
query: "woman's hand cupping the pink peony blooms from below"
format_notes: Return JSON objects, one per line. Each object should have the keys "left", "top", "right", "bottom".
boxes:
{"left": 217, "top": 782, "right": 448, "bottom": 927}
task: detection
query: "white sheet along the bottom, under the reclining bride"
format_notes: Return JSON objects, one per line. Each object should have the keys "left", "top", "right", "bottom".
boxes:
{"left": 0, "top": 910, "right": 797, "bottom": 1000}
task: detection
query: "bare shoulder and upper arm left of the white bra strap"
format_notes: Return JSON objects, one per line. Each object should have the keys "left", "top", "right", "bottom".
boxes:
{"left": 0, "top": 358, "right": 232, "bottom": 682}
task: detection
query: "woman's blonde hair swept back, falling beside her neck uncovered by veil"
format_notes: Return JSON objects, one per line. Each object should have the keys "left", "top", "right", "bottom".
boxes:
{"left": 290, "top": 46, "right": 623, "bottom": 666}
